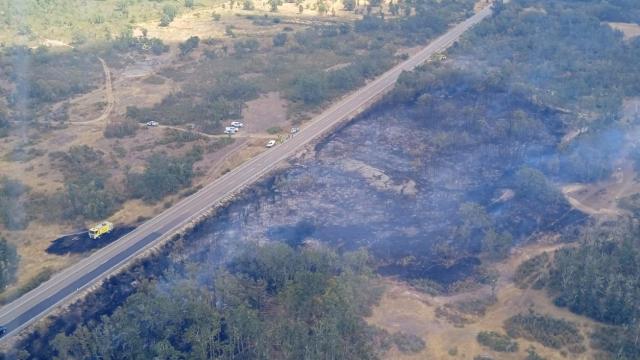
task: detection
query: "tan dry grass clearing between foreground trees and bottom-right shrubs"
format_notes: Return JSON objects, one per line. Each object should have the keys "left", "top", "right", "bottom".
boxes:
{"left": 368, "top": 240, "right": 594, "bottom": 359}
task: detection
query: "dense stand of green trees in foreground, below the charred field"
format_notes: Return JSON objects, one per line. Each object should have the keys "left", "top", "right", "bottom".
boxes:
{"left": 47, "top": 244, "right": 380, "bottom": 359}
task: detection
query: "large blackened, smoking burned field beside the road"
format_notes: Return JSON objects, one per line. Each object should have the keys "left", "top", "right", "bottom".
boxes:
{"left": 175, "top": 71, "right": 585, "bottom": 284}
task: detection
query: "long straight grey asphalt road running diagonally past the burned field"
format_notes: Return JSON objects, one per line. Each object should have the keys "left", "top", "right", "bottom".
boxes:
{"left": 0, "top": 8, "right": 491, "bottom": 340}
